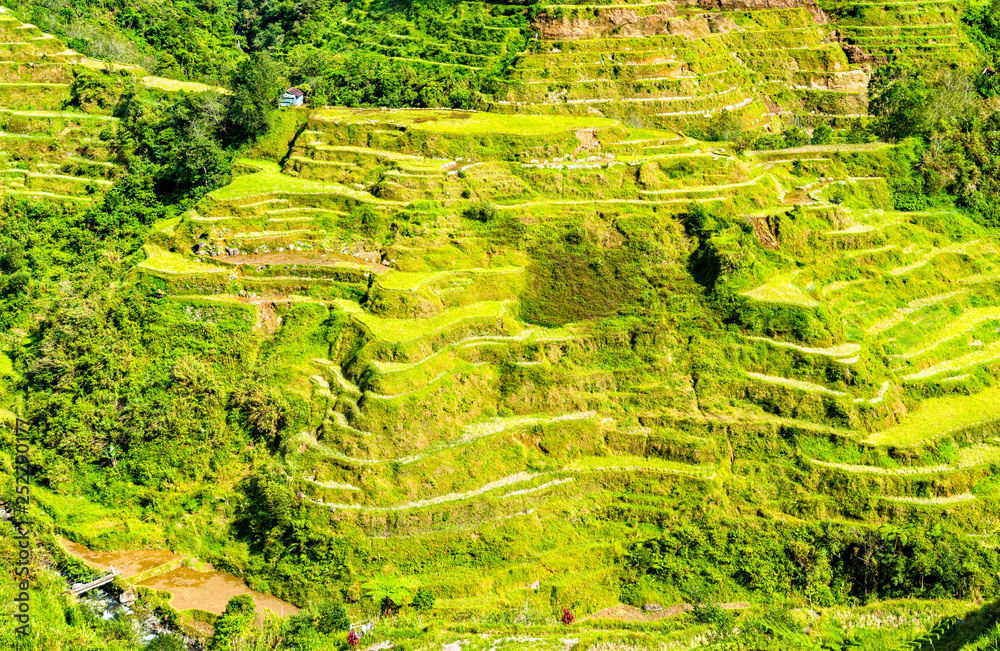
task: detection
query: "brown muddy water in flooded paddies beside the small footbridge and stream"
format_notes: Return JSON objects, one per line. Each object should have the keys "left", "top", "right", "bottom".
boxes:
{"left": 61, "top": 539, "right": 299, "bottom": 616}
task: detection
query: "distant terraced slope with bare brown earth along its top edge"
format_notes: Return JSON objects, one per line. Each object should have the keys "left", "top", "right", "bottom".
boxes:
{"left": 495, "top": 2, "right": 975, "bottom": 127}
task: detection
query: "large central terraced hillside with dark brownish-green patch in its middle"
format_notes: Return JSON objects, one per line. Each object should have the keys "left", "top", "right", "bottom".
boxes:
{"left": 125, "top": 109, "right": 1000, "bottom": 632}
